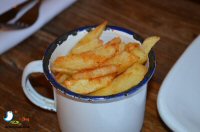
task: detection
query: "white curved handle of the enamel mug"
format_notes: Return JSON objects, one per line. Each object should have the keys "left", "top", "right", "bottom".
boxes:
{"left": 21, "top": 60, "right": 56, "bottom": 112}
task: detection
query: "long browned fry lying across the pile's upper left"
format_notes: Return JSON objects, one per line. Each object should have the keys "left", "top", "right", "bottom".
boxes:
{"left": 52, "top": 38, "right": 121, "bottom": 72}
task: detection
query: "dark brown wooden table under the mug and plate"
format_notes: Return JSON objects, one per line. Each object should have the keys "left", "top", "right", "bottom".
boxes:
{"left": 0, "top": 0, "right": 200, "bottom": 132}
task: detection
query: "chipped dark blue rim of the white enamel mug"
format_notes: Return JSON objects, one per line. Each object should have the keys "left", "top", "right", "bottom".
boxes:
{"left": 43, "top": 25, "right": 156, "bottom": 102}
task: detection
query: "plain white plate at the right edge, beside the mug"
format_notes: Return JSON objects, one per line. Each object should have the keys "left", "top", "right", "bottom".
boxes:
{"left": 157, "top": 36, "right": 200, "bottom": 132}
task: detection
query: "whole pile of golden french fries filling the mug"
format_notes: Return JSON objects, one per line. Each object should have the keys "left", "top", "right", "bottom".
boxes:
{"left": 51, "top": 21, "right": 160, "bottom": 96}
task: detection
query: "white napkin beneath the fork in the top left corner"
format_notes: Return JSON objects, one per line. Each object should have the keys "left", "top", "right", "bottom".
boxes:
{"left": 0, "top": 0, "right": 76, "bottom": 54}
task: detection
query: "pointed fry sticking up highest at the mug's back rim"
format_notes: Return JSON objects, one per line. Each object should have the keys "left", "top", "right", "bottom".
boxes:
{"left": 71, "top": 21, "right": 107, "bottom": 54}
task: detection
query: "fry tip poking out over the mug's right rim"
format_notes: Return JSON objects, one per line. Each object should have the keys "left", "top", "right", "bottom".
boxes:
{"left": 141, "top": 36, "right": 160, "bottom": 55}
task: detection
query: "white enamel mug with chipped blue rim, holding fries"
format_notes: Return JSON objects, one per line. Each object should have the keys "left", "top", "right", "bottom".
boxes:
{"left": 22, "top": 26, "right": 155, "bottom": 132}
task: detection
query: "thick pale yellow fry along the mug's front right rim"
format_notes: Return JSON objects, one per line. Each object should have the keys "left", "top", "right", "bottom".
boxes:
{"left": 89, "top": 63, "right": 147, "bottom": 96}
